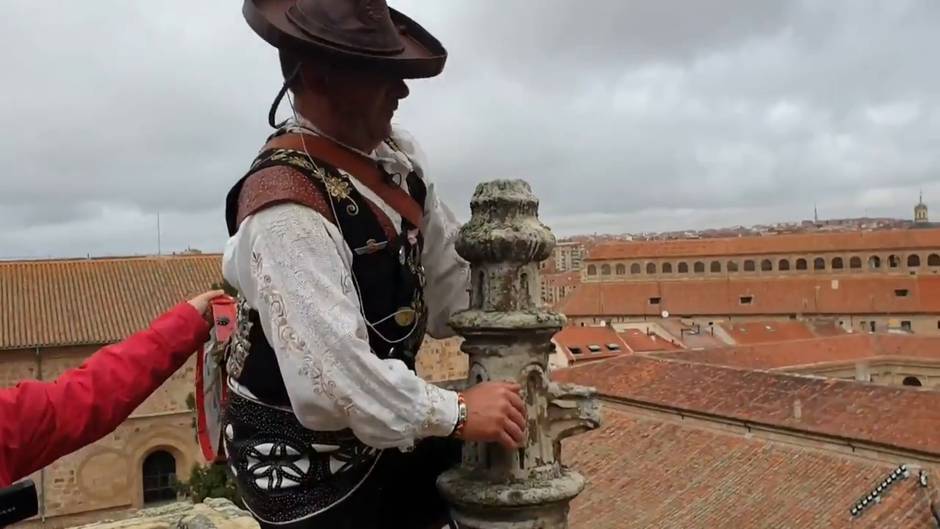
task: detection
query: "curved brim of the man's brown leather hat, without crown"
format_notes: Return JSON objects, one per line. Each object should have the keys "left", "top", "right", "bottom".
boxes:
{"left": 242, "top": 0, "right": 447, "bottom": 79}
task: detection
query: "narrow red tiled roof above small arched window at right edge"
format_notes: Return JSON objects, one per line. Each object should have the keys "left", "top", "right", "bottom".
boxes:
{"left": 658, "top": 334, "right": 940, "bottom": 369}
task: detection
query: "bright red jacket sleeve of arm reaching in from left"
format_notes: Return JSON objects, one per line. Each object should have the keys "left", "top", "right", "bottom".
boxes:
{"left": 0, "top": 303, "right": 209, "bottom": 486}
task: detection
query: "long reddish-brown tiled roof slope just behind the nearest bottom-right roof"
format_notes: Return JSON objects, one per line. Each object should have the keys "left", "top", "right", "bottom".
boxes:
{"left": 554, "top": 355, "right": 940, "bottom": 455}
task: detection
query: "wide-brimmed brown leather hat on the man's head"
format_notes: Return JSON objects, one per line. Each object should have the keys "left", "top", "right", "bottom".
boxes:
{"left": 242, "top": 0, "right": 447, "bottom": 79}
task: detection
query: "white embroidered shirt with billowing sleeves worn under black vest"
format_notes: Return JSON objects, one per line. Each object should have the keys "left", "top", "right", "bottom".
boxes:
{"left": 222, "top": 124, "right": 469, "bottom": 449}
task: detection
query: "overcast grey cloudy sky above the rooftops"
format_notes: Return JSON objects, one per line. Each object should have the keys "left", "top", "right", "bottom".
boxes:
{"left": 0, "top": 0, "right": 940, "bottom": 258}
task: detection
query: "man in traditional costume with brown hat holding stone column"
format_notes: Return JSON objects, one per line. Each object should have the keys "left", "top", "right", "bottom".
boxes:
{"left": 221, "top": 0, "right": 525, "bottom": 529}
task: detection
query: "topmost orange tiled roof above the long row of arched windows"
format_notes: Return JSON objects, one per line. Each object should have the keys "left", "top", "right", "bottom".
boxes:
{"left": 588, "top": 229, "right": 940, "bottom": 261}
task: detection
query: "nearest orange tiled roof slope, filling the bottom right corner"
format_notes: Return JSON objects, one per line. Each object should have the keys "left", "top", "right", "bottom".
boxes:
{"left": 564, "top": 406, "right": 940, "bottom": 529}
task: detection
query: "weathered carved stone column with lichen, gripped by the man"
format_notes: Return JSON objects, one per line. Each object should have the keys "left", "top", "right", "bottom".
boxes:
{"left": 438, "top": 180, "right": 600, "bottom": 529}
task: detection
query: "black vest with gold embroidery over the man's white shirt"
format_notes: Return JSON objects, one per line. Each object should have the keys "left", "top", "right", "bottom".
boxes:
{"left": 225, "top": 136, "right": 427, "bottom": 406}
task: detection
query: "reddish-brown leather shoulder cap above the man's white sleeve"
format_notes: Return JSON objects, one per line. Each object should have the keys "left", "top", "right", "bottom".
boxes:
{"left": 236, "top": 165, "right": 336, "bottom": 225}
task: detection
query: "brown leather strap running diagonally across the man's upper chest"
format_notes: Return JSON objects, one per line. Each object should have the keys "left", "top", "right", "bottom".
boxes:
{"left": 263, "top": 133, "right": 424, "bottom": 229}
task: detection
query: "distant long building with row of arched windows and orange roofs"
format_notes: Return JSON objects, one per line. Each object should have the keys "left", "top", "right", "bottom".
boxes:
{"left": 559, "top": 225, "right": 940, "bottom": 334}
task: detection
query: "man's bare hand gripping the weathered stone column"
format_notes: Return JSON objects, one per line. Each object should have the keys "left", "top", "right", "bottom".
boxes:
{"left": 460, "top": 382, "right": 525, "bottom": 449}
